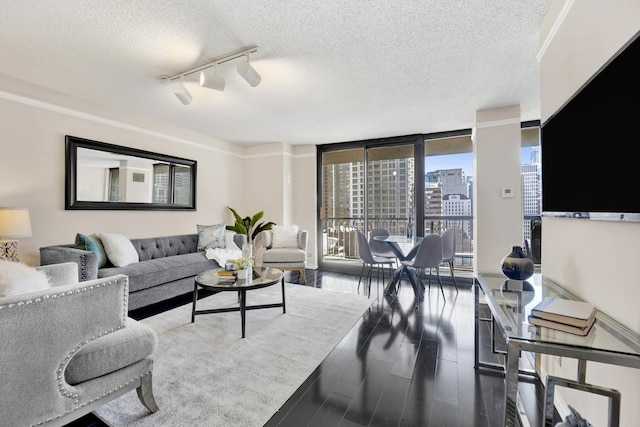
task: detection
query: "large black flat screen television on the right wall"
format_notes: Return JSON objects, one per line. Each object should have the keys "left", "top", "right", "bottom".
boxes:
{"left": 541, "top": 32, "right": 640, "bottom": 221}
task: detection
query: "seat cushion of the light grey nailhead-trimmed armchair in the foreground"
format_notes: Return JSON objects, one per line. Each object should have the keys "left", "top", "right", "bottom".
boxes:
{"left": 65, "top": 318, "right": 158, "bottom": 385}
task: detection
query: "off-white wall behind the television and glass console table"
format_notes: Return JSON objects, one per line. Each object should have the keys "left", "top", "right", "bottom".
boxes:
{"left": 540, "top": 0, "right": 640, "bottom": 427}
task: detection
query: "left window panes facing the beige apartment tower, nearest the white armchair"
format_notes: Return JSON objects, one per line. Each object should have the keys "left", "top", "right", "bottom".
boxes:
{"left": 318, "top": 136, "right": 423, "bottom": 265}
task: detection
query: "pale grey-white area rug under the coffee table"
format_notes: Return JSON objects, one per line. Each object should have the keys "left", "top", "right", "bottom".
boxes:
{"left": 95, "top": 284, "right": 374, "bottom": 427}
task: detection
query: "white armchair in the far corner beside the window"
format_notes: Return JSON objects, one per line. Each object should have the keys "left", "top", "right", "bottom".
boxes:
{"left": 254, "top": 230, "right": 308, "bottom": 284}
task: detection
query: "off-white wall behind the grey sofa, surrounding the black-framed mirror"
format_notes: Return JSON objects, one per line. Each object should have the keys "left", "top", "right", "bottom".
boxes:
{"left": 0, "top": 76, "right": 247, "bottom": 265}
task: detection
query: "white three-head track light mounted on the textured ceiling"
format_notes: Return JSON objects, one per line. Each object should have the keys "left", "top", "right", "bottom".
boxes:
{"left": 160, "top": 46, "right": 262, "bottom": 105}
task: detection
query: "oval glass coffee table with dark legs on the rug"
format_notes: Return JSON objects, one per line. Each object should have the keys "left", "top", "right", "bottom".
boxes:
{"left": 191, "top": 267, "right": 287, "bottom": 338}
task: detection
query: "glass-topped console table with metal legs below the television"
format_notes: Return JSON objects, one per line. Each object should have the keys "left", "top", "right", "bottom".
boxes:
{"left": 474, "top": 273, "right": 640, "bottom": 426}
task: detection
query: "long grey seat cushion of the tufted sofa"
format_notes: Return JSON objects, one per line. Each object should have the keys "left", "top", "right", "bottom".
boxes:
{"left": 98, "top": 252, "right": 218, "bottom": 292}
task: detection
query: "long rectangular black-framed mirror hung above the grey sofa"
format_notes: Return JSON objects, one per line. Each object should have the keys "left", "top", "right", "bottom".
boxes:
{"left": 65, "top": 135, "right": 197, "bottom": 210}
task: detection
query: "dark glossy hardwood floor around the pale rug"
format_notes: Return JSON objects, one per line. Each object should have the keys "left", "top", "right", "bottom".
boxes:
{"left": 69, "top": 270, "right": 543, "bottom": 427}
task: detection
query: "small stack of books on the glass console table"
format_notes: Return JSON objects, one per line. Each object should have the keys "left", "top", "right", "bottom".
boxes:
{"left": 529, "top": 297, "right": 596, "bottom": 336}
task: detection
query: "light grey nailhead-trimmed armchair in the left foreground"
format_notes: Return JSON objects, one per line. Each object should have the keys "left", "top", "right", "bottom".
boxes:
{"left": 0, "top": 262, "right": 158, "bottom": 426}
